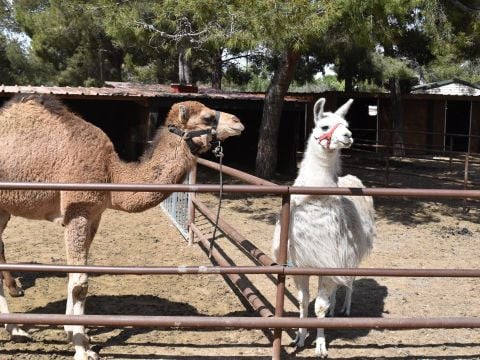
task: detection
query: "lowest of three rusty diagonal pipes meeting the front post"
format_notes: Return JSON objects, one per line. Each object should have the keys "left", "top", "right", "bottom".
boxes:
{"left": 191, "top": 224, "right": 273, "bottom": 317}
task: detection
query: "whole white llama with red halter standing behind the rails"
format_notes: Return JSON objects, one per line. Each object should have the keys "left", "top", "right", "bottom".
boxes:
{"left": 273, "top": 99, "right": 375, "bottom": 357}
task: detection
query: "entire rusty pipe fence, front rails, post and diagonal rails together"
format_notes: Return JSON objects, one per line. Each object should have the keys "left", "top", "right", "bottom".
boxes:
{"left": 0, "top": 169, "right": 480, "bottom": 359}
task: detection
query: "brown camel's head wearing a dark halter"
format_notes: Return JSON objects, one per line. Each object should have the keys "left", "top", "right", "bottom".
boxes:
{"left": 166, "top": 101, "right": 245, "bottom": 153}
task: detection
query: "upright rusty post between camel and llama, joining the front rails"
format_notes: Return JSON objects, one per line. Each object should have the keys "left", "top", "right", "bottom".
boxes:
{"left": 272, "top": 194, "right": 290, "bottom": 360}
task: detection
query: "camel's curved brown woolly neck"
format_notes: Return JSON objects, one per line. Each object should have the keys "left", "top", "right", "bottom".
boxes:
{"left": 110, "top": 129, "right": 195, "bottom": 212}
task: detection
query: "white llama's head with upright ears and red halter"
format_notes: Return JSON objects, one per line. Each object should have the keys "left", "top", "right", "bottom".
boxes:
{"left": 312, "top": 98, "right": 353, "bottom": 151}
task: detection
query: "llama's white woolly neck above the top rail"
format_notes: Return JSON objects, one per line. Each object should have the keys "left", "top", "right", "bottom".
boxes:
{"left": 295, "top": 139, "right": 341, "bottom": 187}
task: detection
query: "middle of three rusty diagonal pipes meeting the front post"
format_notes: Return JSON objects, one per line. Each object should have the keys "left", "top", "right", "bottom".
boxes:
{"left": 192, "top": 198, "right": 275, "bottom": 266}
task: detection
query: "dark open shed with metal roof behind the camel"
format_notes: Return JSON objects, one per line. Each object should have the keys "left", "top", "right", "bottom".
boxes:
{"left": 0, "top": 83, "right": 308, "bottom": 173}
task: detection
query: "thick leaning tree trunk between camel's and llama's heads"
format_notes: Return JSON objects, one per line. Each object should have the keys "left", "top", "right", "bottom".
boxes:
{"left": 255, "top": 50, "right": 300, "bottom": 179}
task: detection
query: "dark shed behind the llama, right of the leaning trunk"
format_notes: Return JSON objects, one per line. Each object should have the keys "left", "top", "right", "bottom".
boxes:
{"left": 297, "top": 87, "right": 480, "bottom": 153}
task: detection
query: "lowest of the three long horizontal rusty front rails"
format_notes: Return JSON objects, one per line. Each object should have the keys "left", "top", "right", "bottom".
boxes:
{"left": 0, "top": 314, "right": 480, "bottom": 330}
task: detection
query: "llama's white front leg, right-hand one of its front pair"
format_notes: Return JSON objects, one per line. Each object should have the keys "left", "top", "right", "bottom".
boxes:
{"left": 315, "top": 277, "right": 337, "bottom": 358}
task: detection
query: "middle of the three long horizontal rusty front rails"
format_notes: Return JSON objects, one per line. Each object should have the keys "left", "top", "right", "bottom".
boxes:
{"left": 0, "top": 264, "right": 480, "bottom": 278}
